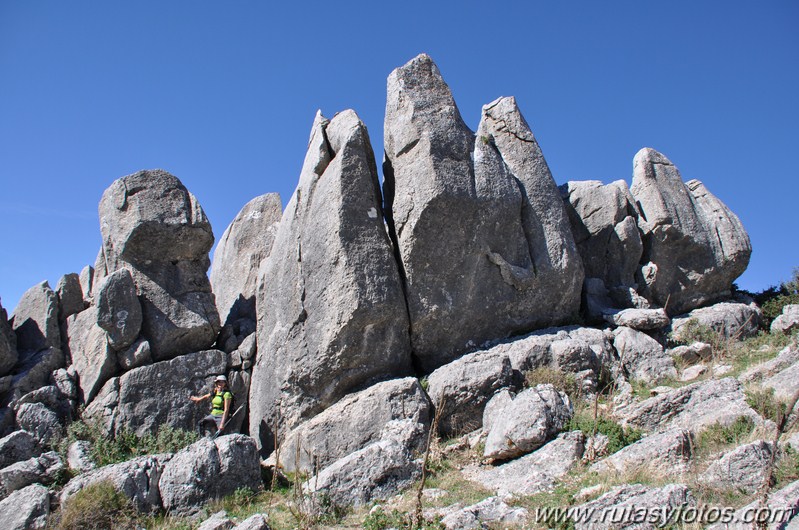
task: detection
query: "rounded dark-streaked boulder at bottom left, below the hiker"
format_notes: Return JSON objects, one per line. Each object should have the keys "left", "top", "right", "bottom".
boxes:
{"left": 158, "top": 434, "right": 262, "bottom": 515}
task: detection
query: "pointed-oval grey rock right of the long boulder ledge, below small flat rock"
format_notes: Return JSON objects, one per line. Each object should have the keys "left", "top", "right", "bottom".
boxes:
{"left": 613, "top": 327, "right": 677, "bottom": 383}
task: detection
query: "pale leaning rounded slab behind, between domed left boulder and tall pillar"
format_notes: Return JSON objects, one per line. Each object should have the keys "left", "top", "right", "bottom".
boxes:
{"left": 210, "top": 193, "right": 283, "bottom": 324}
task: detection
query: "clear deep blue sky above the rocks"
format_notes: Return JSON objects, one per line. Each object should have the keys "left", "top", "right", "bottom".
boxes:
{"left": 0, "top": 0, "right": 799, "bottom": 312}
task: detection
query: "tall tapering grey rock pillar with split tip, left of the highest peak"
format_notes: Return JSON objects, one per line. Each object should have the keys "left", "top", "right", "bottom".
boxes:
{"left": 250, "top": 111, "right": 411, "bottom": 450}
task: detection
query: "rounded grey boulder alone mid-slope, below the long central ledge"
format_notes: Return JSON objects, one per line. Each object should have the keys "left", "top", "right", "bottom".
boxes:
{"left": 483, "top": 385, "right": 574, "bottom": 459}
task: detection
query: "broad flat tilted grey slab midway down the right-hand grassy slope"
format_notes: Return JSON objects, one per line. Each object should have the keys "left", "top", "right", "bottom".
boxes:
{"left": 620, "top": 377, "right": 763, "bottom": 434}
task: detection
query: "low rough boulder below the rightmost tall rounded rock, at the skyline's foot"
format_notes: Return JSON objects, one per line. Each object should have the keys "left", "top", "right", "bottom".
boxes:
{"left": 671, "top": 302, "right": 761, "bottom": 340}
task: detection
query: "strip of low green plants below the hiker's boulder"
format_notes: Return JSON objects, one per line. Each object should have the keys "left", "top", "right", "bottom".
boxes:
{"left": 56, "top": 420, "right": 199, "bottom": 466}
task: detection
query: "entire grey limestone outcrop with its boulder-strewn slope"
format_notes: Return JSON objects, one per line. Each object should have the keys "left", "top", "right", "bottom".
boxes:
{"left": 0, "top": 55, "right": 799, "bottom": 528}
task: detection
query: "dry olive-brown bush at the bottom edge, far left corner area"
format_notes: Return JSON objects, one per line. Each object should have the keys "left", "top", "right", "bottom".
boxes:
{"left": 55, "top": 481, "right": 139, "bottom": 530}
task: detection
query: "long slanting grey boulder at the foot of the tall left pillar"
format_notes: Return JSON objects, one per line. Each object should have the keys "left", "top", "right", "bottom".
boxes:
{"left": 280, "top": 377, "right": 432, "bottom": 472}
